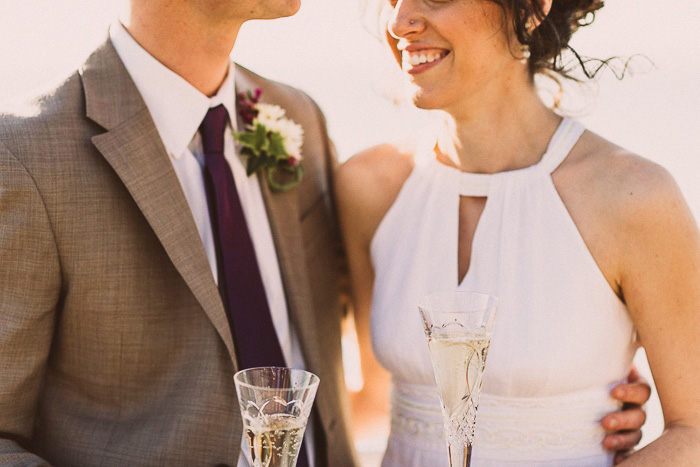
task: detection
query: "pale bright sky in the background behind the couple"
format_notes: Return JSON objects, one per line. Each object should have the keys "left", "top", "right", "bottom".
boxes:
{"left": 0, "top": 0, "right": 700, "bottom": 460}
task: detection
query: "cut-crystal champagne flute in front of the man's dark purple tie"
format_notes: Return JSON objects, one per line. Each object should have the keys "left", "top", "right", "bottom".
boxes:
{"left": 233, "top": 367, "right": 320, "bottom": 467}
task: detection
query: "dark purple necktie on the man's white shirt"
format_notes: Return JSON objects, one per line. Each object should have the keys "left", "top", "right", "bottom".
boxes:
{"left": 199, "top": 105, "right": 309, "bottom": 467}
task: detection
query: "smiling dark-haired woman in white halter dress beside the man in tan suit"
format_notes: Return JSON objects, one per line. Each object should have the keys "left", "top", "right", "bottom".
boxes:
{"left": 336, "top": 0, "right": 700, "bottom": 467}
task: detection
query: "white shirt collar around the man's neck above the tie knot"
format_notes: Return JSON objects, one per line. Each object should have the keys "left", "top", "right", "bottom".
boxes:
{"left": 109, "top": 22, "right": 236, "bottom": 159}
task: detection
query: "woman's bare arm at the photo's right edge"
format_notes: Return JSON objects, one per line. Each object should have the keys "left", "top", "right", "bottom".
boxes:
{"left": 613, "top": 156, "right": 700, "bottom": 467}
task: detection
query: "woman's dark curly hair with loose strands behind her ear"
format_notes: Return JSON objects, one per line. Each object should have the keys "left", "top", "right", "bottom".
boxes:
{"left": 490, "top": 0, "right": 626, "bottom": 81}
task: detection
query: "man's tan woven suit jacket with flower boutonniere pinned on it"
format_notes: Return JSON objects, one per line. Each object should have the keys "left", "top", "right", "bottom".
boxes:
{"left": 0, "top": 41, "right": 356, "bottom": 466}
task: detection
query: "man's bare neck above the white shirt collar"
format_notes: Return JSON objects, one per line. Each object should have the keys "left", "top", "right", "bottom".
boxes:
{"left": 122, "top": 2, "right": 242, "bottom": 96}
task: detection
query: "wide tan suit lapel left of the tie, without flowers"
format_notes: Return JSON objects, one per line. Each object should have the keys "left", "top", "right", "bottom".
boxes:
{"left": 80, "top": 40, "right": 236, "bottom": 365}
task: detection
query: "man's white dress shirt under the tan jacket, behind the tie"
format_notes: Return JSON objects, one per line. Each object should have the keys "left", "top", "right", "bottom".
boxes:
{"left": 110, "top": 22, "right": 313, "bottom": 467}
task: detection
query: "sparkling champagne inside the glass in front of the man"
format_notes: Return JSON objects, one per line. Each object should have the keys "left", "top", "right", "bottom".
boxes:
{"left": 245, "top": 414, "right": 306, "bottom": 467}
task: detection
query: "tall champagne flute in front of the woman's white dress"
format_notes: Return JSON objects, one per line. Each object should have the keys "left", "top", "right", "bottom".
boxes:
{"left": 418, "top": 292, "right": 498, "bottom": 467}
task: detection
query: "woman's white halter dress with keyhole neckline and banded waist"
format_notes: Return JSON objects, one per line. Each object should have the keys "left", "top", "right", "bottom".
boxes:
{"left": 371, "top": 119, "right": 636, "bottom": 467}
